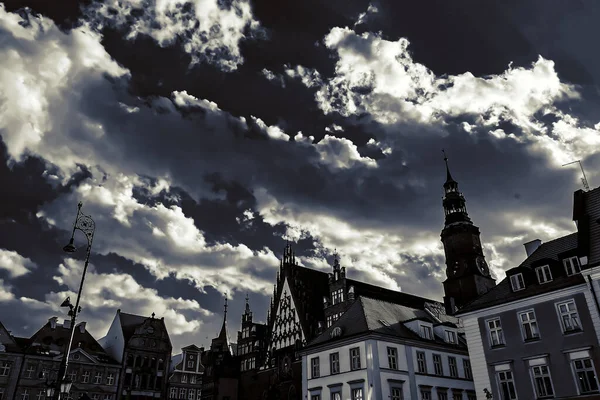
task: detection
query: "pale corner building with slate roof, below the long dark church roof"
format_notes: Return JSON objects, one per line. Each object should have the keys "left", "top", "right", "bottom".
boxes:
{"left": 301, "top": 297, "right": 475, "bottom": 400}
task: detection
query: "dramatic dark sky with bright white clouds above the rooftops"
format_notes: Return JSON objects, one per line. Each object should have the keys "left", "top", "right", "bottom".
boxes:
{"left": 0, "top": 0, "right": 600, "bottom": 352}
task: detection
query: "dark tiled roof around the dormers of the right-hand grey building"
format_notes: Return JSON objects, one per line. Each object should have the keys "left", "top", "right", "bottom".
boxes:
{"left": 457, "top": 232, "right": 585, "bottom": 315}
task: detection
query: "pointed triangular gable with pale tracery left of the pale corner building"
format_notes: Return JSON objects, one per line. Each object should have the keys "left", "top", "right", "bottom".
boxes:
{"left": 269, "top": 278, "right": 306, "bottom": 351}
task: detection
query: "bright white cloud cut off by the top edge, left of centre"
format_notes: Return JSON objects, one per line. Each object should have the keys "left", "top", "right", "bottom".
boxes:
{"left": 87, "top": 0, "right": 260, "bottom": 71}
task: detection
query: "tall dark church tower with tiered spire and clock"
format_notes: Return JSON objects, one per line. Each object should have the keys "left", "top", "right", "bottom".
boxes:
{"left": 441, "top": 152, "right": 496, "bottom": 314}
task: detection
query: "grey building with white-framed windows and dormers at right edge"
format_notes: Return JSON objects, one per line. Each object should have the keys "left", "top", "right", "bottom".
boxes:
{"left": 457, "top": 189, "right": 600, "bottom": 400}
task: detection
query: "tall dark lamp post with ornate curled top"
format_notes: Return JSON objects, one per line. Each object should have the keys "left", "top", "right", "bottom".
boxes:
{"left": 53, "top": 202, "right": 96, "bottom": 400}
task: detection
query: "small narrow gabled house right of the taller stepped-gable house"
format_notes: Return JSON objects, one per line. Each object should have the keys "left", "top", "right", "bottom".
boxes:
{"left": 168, "top": 344, "right": 204, "bottom": 400}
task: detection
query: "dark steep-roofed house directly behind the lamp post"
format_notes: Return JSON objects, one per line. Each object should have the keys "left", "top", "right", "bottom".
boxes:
{"left": 16, "top": 317, "right": 120, "bottom": 400}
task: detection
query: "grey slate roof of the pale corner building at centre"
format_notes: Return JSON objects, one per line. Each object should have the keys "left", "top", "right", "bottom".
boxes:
{"left": 308, "top": 297, "right": 465, "bottom": 347}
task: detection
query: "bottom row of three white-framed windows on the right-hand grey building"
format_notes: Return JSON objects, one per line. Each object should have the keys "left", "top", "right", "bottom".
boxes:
{"left": 496, "top": 358, "right": 598, "bottom": 400}
